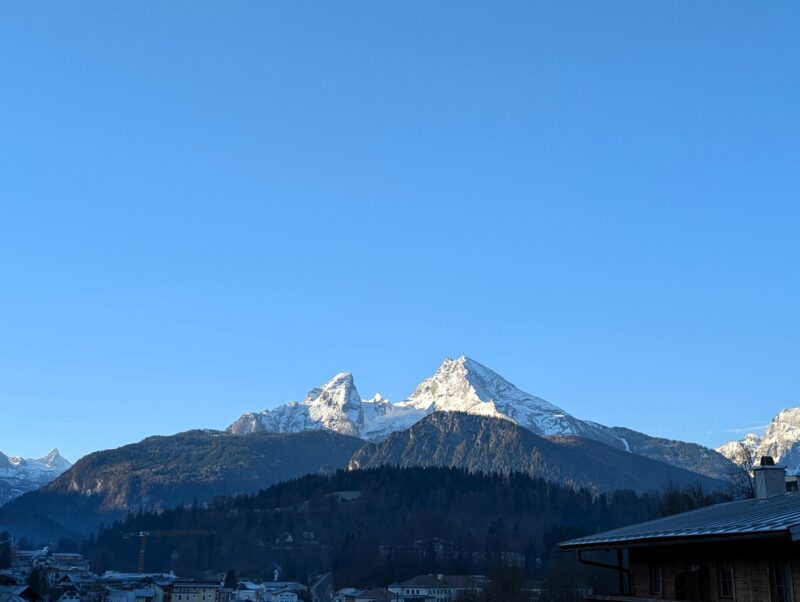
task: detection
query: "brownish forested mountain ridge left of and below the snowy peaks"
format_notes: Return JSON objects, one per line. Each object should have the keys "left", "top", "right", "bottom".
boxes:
{"left": 0, "top": 430, "right": 363, "bottom": 534}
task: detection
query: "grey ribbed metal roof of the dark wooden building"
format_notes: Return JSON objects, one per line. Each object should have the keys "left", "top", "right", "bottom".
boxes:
{"left": 559, "top": 492, "right": 800, "bottom": 550}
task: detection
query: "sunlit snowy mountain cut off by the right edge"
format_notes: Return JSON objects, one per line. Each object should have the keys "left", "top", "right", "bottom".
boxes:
{"left": 717, "top": 408, "right": 800, "bottom": 475}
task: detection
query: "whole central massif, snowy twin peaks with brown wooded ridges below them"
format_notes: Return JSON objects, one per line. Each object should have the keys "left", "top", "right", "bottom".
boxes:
{"left": 0, "top": 356, "right": 738, "bottom": 538}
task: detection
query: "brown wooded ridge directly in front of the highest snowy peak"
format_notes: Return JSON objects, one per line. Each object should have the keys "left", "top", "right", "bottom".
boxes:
{"left": 348, "top": 411, "right": 727, "bottom": 493}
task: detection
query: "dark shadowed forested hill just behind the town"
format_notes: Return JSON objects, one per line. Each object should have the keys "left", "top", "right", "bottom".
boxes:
{"left": 84, "top": 467, "right": 724, "bottom": 586}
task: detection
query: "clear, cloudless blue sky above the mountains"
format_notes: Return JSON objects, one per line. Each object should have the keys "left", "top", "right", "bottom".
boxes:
{"left": 0, "top": 0, "right": 800, "bottom": 460}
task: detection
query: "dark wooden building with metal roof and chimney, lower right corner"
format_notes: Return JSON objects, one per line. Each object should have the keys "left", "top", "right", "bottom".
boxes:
{"left": 559, "top": 458, "right": 800, "bottom": 602}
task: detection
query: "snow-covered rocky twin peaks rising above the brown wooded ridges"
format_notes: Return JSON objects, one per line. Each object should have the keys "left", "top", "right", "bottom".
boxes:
{"left": 227, "top": 356, "right": 734, "bottom": 479}
